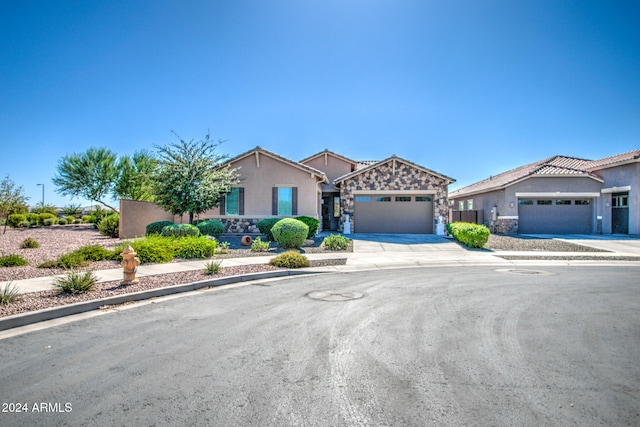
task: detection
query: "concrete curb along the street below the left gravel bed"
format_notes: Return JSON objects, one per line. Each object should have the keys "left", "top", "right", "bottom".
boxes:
{"left": 0, "top": 270, "right": 324, "bottom": 331}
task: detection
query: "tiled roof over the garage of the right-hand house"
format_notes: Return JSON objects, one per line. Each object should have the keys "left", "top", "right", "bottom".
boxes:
{"left": 449, "top": 156, "right": 602, "bottom": 198}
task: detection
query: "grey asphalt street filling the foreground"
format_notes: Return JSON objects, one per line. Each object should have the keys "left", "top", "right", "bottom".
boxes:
{"left": 0, "top": 266, "right": 640, "bottom": 426}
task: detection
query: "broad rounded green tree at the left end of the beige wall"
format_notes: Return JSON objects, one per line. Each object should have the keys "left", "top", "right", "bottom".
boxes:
{"left": 52, "top": 147, "right": 119, "bottom": 212}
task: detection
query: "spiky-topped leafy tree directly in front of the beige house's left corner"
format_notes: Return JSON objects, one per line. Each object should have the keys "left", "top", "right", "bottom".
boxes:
{"left": 153, "top": 132, "right": 238, "bottom": 224}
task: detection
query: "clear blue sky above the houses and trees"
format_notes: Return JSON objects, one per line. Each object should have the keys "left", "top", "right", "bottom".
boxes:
{"left": 0, "top": 0, "right": 640, "bottom": 206}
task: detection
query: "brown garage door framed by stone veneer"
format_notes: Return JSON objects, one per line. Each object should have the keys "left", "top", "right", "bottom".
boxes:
{"left": 354, "top": 194, "right": 433, "bottom": 234}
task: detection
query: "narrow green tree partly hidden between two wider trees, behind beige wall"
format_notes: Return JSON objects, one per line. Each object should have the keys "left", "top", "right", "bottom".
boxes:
{"left": 113, "top": 150, "right": 158, "bottom": 202}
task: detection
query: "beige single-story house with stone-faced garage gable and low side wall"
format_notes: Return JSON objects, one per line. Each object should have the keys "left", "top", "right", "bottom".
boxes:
{"left": 120, "top": 147, "right": 454, "bottom": 237}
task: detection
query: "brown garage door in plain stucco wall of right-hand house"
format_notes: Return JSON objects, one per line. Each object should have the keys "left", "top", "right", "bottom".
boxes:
{"left": 518, "top": 199, "right": 593, "bottom": 234}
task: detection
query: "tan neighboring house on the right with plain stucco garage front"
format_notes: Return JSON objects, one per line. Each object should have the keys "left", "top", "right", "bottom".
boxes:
{"left": 449, "top": 150, "right": 640, "bottom": 234}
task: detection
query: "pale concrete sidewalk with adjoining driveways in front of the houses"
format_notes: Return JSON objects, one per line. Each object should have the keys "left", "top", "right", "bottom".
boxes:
{"left": 5, "top": 234, "right": 640, "bottom": 293}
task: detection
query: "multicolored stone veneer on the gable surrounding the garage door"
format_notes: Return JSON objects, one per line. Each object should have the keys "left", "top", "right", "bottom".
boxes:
{"left": 339, "top": 159, "right": 449, "bottom": 232}
